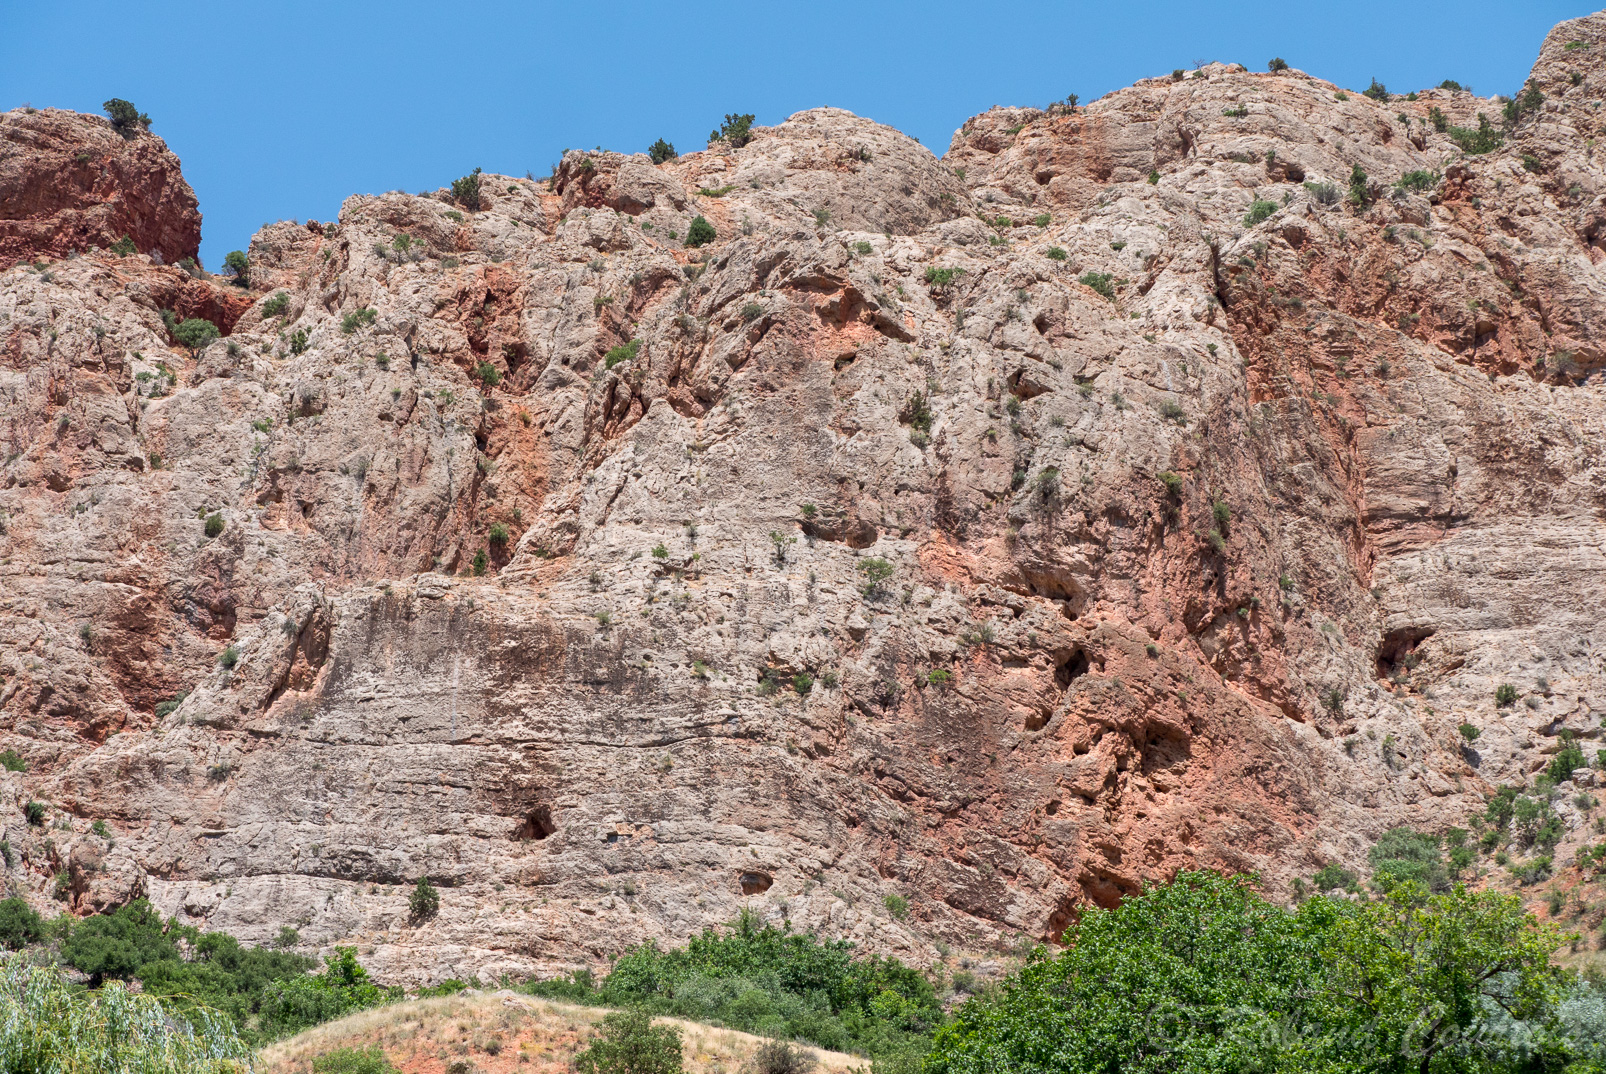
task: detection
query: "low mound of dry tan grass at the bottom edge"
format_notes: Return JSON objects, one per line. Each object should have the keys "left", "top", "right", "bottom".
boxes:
{"left": 259, "top": 992, "right": 870, "bottom": 1074}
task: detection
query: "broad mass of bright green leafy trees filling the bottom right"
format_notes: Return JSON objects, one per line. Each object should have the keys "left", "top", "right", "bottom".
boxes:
{"left": 923, "top": 872, "right": 1573, "bottom": 1074}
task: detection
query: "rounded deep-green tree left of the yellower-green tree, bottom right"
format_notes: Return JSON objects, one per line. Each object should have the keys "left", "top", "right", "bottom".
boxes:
{"left": 925, "top": 872, "right": 1339, "bottom": 1074}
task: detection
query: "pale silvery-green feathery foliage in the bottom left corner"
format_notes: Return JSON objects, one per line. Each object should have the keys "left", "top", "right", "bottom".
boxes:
{"left": 0, "top": 955, "right": 251, "bottom": 1074}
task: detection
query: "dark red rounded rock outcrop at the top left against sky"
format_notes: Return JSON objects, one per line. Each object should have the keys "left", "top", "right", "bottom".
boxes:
{"left": 0, "top": 109, "right": 201, "bottom": 270}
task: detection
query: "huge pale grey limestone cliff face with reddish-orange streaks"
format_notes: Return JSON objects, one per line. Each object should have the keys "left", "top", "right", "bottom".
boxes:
{"left": 0, "top": 14, "right": 1606, "bottom": 982}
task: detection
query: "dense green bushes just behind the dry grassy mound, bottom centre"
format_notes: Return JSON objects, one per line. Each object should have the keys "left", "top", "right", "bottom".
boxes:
{"left": 525, "top": 913, "right": 943, "bottom": 1056}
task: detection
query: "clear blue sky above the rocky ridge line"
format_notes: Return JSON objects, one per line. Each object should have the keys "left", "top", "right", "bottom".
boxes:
{"left": 0, "top": 0, "right": 1606, "bottom": 270}
